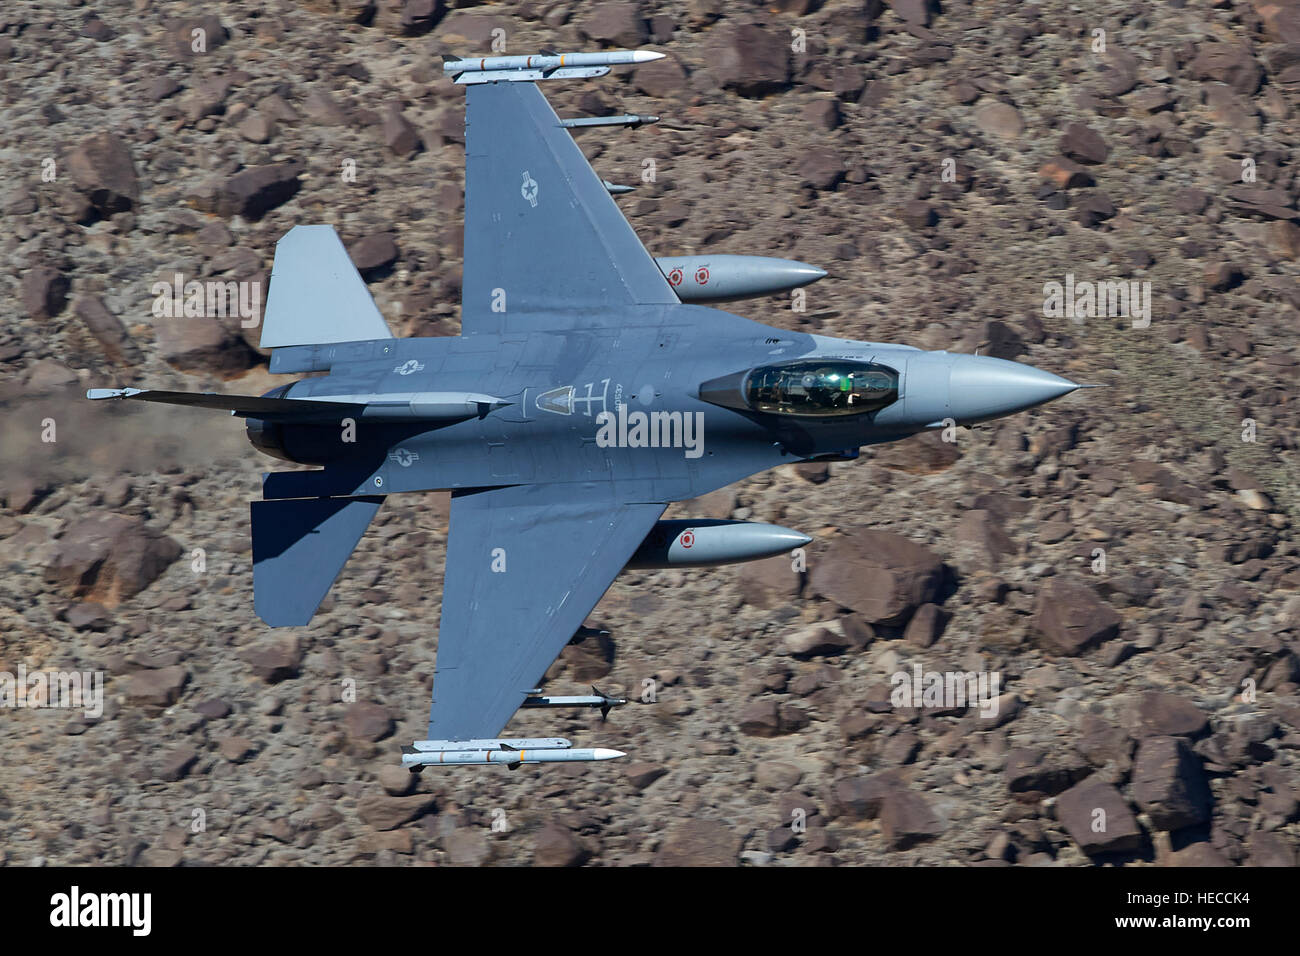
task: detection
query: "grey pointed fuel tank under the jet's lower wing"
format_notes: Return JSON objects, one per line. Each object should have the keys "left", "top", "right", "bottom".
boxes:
{"left": 627, "top": 519, "right": 813, "bottom": 570}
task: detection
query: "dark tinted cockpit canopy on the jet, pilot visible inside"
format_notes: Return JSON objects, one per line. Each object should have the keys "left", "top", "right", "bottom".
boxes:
{"left": 699, "top": 359, "right": 898, "bottom": 418}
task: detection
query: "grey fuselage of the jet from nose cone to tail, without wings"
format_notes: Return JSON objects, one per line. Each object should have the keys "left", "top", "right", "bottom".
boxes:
{"left": 255, "top": 306, "right": 1075, "bottom": 501}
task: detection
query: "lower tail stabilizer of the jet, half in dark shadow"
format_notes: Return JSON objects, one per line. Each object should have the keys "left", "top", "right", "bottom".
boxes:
{"left": 250, "top": 496, "right": 384, "bottom": 627}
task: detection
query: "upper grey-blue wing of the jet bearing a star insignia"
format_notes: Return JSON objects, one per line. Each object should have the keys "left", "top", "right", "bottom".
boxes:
{"left": 462, "top": 74, "right": 680, "bottom": 336}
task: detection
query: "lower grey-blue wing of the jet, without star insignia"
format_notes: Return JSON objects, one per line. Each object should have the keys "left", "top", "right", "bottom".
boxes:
{"left": 429, "top": 485, "right": 666, "bottom": 740}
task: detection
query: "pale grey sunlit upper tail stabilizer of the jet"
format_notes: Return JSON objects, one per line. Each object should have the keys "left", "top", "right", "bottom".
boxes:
{"left": 261, "top": 226, "right": 393, "bottom": 349}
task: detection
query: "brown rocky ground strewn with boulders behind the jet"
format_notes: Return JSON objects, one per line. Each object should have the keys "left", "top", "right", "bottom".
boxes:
{"left": 0, "top": 0, "right": 1300, "bottom": 866}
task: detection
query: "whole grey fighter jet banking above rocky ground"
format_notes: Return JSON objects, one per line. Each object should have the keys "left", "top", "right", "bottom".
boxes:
{"left": 88, "top": 51, "right": 1080, "bottom": 771}
